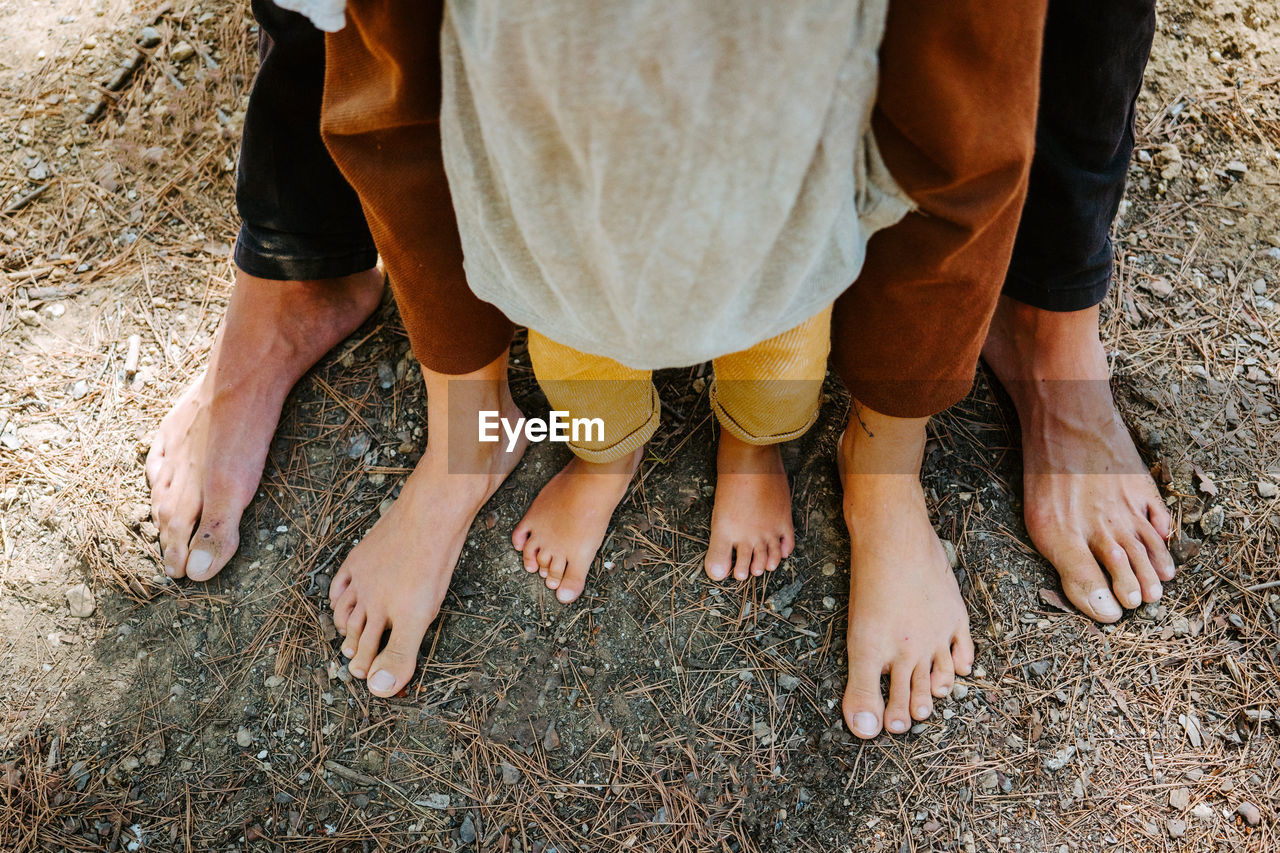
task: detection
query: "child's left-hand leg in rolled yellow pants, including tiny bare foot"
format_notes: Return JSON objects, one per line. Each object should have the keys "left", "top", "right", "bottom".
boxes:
{"left": 511, "top": 329, "right": 659, "bottom": 605}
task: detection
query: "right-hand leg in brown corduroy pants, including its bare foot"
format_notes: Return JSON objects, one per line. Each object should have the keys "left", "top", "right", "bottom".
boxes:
{"left": 832, "top": 0, "right": 1044, "bottom": 738}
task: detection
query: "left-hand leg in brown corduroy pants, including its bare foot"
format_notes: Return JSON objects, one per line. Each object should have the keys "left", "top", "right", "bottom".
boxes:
{"left": 321, "top": 0, "right": 525, "bottom": 697}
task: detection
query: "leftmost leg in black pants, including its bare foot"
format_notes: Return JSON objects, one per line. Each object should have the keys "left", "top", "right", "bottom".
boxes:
{"left": 146, "top": 0, "right": 383, "bottom": 580}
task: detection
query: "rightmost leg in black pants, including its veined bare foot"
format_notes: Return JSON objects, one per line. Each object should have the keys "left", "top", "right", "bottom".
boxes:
{"left": 983, "top": 0, "right": 1174, "bottom": 622}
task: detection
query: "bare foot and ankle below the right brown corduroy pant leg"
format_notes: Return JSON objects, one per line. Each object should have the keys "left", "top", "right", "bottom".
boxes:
{"left": 838, "top": 407, "right": 974, "bottom": 738}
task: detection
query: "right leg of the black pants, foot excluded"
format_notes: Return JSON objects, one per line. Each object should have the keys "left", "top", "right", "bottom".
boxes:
{"left": 1004, "top": 0, "right": 1156, "bottom": 311}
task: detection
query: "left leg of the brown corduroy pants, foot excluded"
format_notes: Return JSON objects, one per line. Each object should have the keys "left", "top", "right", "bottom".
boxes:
{"left": 320, "top": 0, "right": 515, "bottom": 375}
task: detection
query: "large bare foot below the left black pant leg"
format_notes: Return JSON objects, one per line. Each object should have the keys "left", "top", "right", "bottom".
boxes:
{"left": 146, "top": 269, "right": 383, "bottom": 580}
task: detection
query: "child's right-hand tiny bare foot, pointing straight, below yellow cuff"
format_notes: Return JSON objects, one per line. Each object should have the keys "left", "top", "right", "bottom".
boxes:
{"left": 707, "top": 429, "right": 795, "bottom": 580}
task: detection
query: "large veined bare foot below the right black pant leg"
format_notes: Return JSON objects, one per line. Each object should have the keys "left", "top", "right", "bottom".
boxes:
{"left": 982, "top": 297, "right": 1174, "bottom": 622}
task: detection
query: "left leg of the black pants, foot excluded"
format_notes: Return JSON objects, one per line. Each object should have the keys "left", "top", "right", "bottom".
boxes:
{"left": 234, "top": 0, "right": 378, "bottom": 280}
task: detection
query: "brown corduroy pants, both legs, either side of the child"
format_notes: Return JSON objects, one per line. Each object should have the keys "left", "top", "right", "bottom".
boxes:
{"left": 321, "top": 0, "right": 1047, "bottom": 418}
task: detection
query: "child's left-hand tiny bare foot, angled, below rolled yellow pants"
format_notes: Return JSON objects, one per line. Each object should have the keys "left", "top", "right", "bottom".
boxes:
{"left": 511, "top": 448, "right": 644, "bottom": 605}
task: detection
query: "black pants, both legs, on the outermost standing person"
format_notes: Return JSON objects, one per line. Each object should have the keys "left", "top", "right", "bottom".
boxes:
{"left": 236, "top": 0, "right": 1156, "bottom": 311}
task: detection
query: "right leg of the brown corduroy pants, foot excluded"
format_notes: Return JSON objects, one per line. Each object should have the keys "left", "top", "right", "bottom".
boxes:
{"left": 832, "top": 0, "right": 1047, "bottom": 418}
